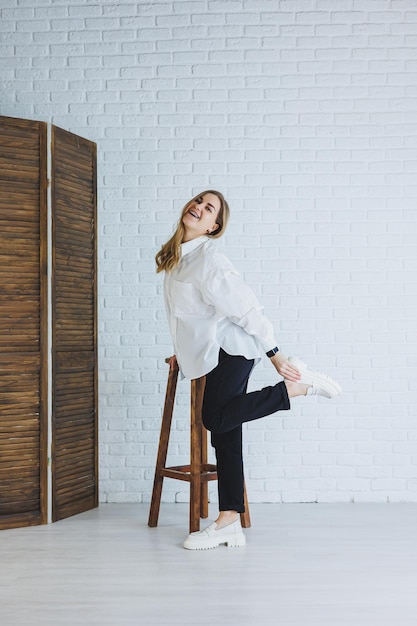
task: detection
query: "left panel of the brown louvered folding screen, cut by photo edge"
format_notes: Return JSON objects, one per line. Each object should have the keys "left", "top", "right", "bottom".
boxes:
{"left": 0, "top": 118, "right": 47, "bottom": 528}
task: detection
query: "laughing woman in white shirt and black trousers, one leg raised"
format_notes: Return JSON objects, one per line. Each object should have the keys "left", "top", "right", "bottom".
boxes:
{"left": 156, "top": 190, "right": 341, "bottom": 550}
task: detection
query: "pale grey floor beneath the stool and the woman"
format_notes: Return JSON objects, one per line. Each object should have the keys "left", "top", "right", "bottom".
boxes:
{"left": 0, "top": 504, "right": 417, "bottom": 626}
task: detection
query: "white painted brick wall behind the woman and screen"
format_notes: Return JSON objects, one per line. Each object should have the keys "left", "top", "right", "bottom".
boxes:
{"left": 0, "top": 0, "right": 417, "bottom": 502}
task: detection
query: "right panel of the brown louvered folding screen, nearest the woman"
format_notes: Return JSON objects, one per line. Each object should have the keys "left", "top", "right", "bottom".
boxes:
{"left": 51, "top": 127, "right": 98, "bottom": 521}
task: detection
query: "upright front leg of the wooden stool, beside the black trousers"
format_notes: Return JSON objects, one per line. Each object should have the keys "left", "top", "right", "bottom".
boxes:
{"left": 190, "top": 378, "right": 205, "bottom": 533}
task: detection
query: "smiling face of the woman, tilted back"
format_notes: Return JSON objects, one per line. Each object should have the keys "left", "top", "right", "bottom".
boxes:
{"left": 182, "top": 193, "right": 221, "bottom": 242}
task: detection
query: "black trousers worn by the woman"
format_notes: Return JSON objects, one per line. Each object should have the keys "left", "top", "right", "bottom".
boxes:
{"left": 203, "top": 349, "right": 290, "bottom": 513}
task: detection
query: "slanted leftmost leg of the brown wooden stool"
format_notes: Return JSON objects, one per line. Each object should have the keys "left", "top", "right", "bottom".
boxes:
{"left": 148, "top": 368, "right": 178, "bottom": 528}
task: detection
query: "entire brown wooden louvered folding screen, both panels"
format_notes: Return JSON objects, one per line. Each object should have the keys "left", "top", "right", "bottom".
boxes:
{"left": 0, "top": 117, "right": 98, "bottom": 529}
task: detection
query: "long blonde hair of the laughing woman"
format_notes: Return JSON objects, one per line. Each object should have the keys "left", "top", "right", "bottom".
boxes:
{"left": 155, "top": 189, "right": 230, "bottom": 272}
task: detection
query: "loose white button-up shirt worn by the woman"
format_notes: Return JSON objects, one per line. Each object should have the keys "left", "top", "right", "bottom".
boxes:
{"left": 164, "top": 237, "right": 277, "bottom": 379}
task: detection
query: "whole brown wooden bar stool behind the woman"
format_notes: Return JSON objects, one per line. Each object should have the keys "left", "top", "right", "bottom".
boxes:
{"left": 148, "top": 359, "right": 250, "bottom": 533}
